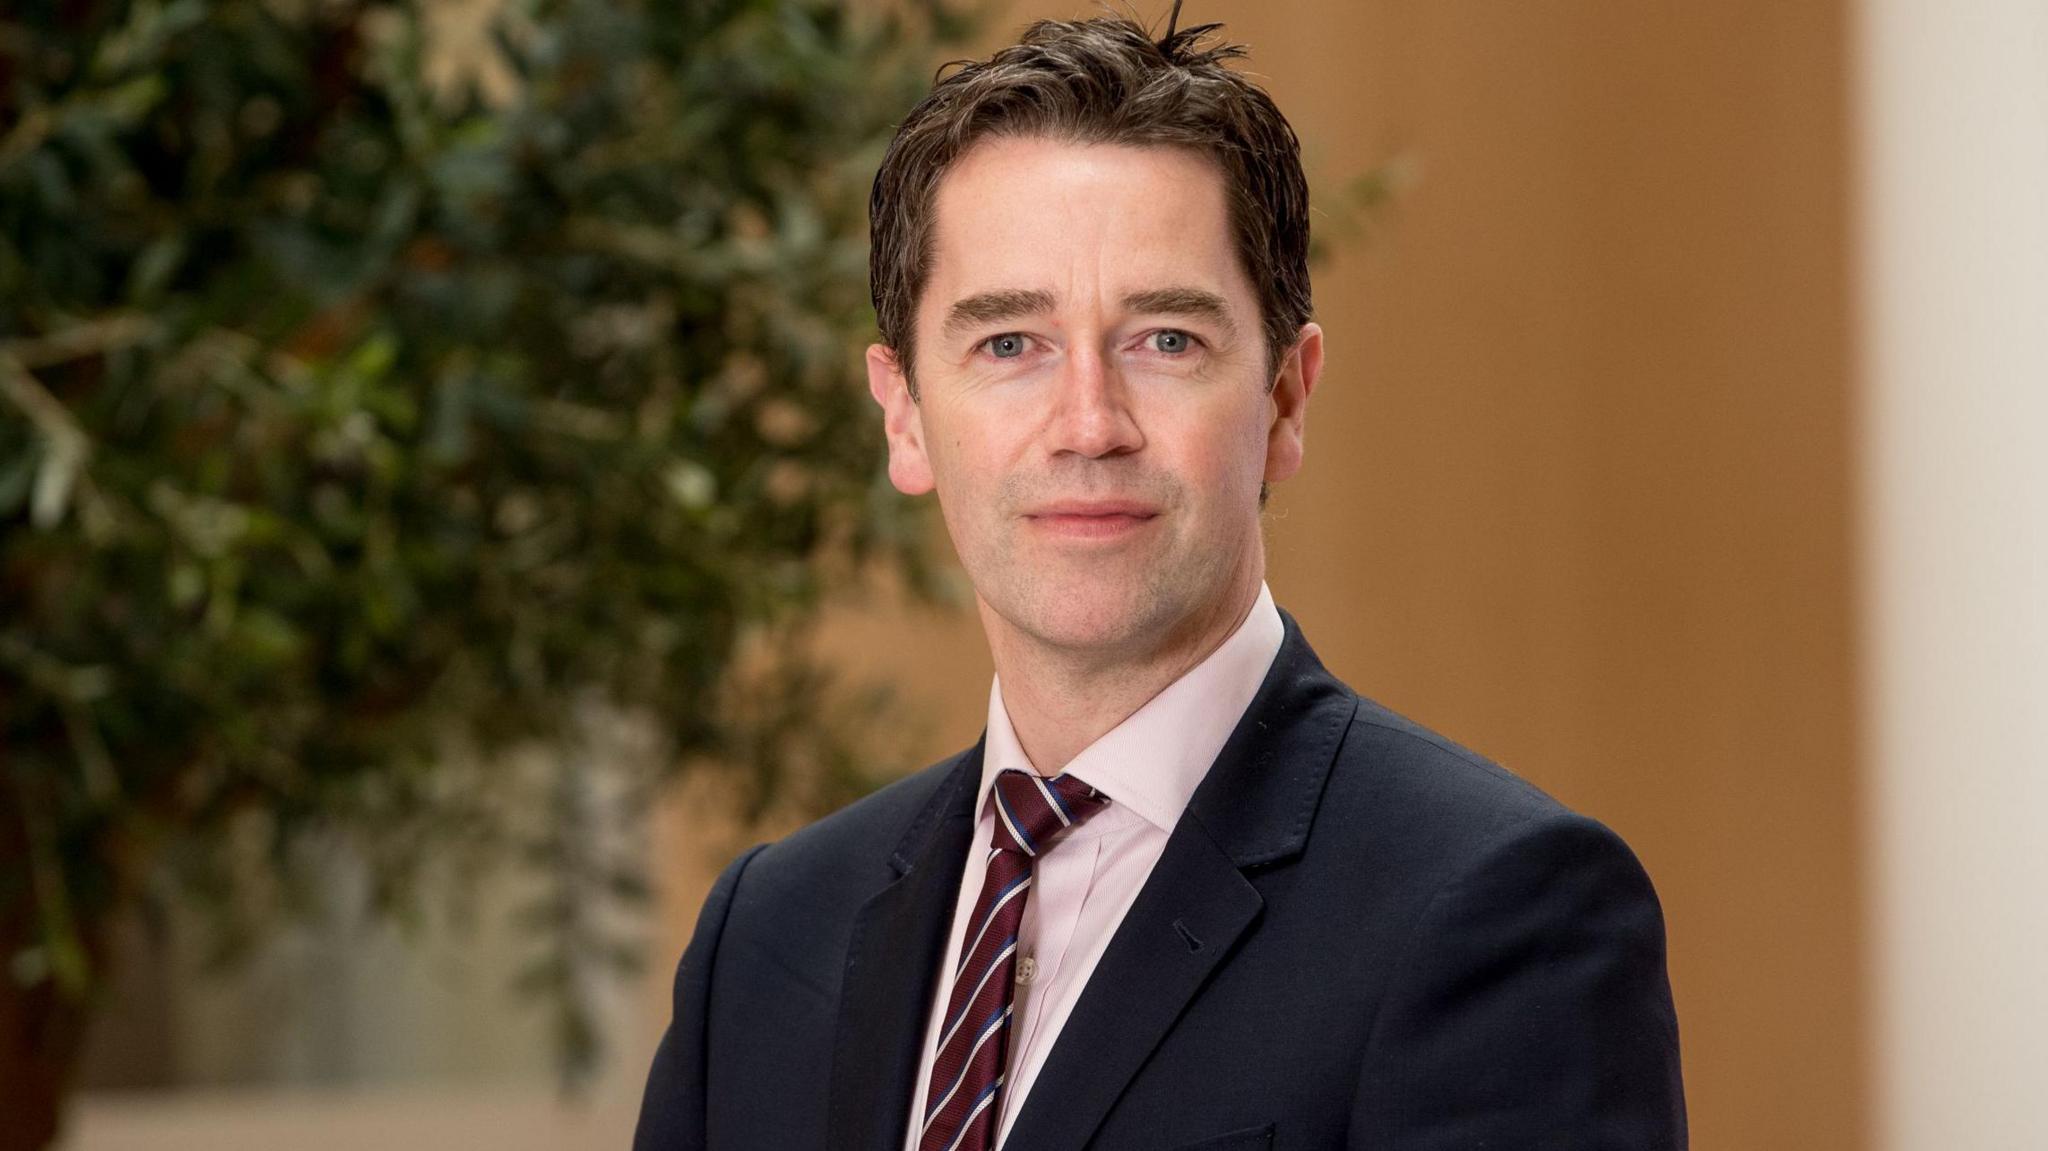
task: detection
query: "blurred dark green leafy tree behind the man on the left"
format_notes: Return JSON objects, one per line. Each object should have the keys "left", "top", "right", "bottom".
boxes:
{"left": 0, "top": 0, "right": 965, "bottom": 1071}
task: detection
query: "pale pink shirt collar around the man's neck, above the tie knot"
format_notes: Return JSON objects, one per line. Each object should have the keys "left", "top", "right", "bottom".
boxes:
{"left": 975, "top": 582, "right": 1286, "bottom": 832}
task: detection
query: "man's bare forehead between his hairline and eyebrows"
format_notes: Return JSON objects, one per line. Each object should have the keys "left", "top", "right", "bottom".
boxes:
{"left": 920, "top": 137, "right": 1251, "bottom": 311}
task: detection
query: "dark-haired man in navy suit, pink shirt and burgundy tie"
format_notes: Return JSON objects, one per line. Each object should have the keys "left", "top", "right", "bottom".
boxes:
{"left": 637, "top": 18, "right": 1686, "bottom": 1151}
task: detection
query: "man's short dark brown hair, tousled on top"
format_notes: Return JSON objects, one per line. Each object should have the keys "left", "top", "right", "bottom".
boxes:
{"left": 868, "top": 4, "right": 1311, "bottom": 399}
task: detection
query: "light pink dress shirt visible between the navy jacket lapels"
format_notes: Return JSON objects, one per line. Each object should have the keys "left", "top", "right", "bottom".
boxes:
{"left": 903, "top": 584, "right": 1284, "bottom": 1151}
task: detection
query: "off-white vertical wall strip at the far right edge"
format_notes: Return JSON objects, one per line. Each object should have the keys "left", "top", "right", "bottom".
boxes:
{"left": 1858, "top": 0, "right": 2048, "bottom": 1151}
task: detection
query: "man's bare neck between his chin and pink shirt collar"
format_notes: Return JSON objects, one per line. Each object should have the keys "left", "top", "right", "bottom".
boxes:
{"left": 979, "top": 571, "right": 1264, "bottom": 776}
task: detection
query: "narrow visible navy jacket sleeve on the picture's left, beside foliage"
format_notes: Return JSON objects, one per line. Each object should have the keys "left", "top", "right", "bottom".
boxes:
{"left": 633, "top": 848, "right": 762, "bottom": 1151}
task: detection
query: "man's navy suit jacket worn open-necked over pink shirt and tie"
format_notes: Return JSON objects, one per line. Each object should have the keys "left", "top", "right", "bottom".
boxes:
{"left": 635, "top": 616, "right": 1686, "bottom": 1151}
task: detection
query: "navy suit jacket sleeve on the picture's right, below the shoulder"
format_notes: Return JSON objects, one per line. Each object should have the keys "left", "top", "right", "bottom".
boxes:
{"left": 1352, "top": 813, "right": 1686, "bottom": 1151}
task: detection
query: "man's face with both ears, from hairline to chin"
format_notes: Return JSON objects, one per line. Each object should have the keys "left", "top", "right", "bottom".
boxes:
{"left": 868, "top": 137, "right": 1321, "bottom": 659}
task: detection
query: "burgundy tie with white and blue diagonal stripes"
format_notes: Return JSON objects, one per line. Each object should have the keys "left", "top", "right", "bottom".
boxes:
{"left": 918, "top": 770, "right": 1110, "bottom": 1151}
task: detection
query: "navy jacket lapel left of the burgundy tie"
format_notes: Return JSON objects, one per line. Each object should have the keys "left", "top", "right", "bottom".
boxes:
{"left": 825, "top": 743, "right": 981, "bottom": 1151}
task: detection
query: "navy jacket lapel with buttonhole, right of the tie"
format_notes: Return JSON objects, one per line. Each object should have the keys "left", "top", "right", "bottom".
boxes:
{"left": 1004, "top": 612, "right": 1358, "bottom": 1151}
